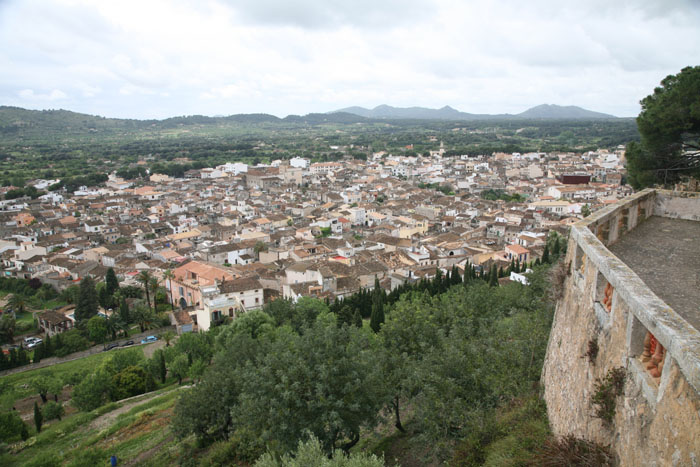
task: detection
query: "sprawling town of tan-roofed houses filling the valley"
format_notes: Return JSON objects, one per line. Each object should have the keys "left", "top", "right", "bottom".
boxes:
{"left": 0, "top": 149, "right": 631, "bottom": 332}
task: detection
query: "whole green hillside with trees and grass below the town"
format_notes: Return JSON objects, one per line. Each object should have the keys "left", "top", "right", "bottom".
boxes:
{"left": 0, "top": 252, "right": 598, "bottom": 466}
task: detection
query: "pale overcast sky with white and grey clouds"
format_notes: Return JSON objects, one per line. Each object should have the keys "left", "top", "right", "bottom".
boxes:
{"left": 0, "top": 0, "right": 700, "bottom": 118}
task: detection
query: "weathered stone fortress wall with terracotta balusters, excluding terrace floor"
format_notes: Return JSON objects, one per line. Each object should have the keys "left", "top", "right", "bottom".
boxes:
{"left": 542, "top": 189, "right": 700, "bottom": 466}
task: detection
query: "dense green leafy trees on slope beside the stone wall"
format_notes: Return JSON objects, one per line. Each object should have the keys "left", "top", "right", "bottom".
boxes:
{"left": 173, "top": 267, "right": 552, "bottom": 462}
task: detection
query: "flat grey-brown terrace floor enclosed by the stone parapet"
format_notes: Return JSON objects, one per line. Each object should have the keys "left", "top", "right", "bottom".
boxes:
{"left": 608, "top": 216, "right": 700, "bottom": 330}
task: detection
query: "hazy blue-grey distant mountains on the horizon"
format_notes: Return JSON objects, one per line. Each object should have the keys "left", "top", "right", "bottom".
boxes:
{"left": 329, "top": 104, "right": 617, "bottom": 120}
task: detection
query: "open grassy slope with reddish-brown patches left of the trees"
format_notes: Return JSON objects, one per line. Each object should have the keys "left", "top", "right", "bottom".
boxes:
{"left": 0, "top": 347, "right": 191, "bottom": 466}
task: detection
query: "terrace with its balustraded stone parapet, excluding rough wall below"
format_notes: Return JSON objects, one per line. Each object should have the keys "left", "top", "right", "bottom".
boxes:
{"left": 569, "top": 189, "right": 700, "bottom": 407}
